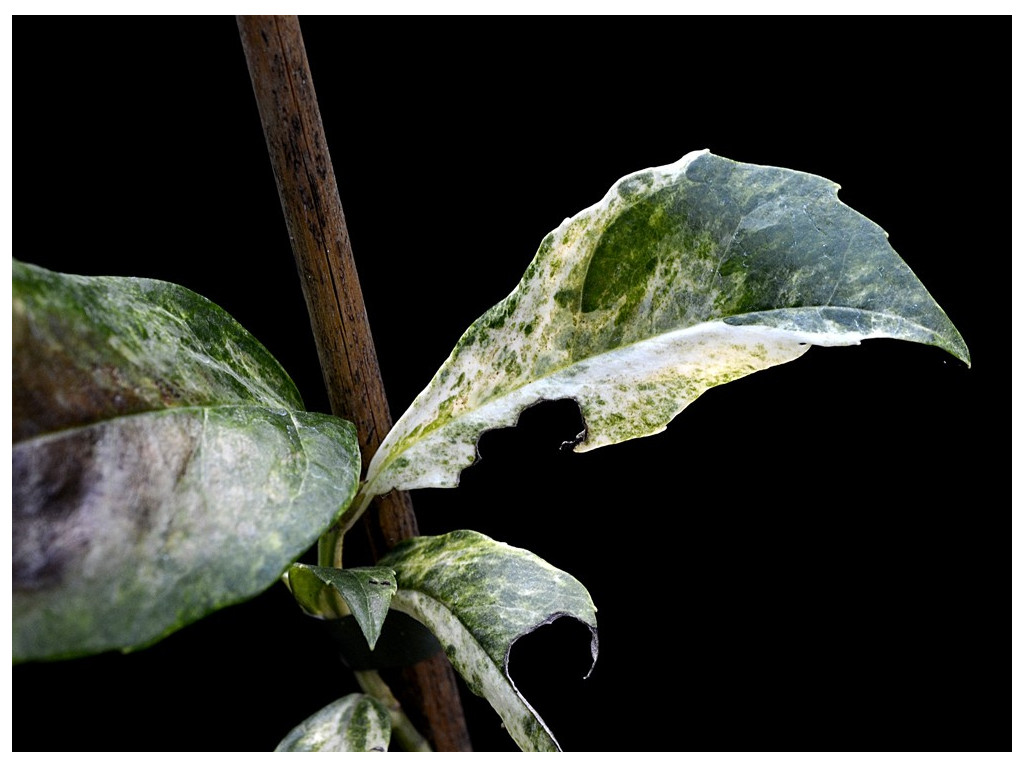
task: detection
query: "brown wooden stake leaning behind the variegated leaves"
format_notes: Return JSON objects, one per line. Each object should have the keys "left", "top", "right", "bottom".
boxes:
{"left": 238, "top": 16, "right": 470, "bottom": 752}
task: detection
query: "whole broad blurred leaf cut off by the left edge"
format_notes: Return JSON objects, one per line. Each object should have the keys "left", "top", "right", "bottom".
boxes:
{"left": 12, "top": 261, "right": 359, "bottom": 662}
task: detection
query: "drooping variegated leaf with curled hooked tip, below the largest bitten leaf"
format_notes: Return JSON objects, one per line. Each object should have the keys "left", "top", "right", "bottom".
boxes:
{"left": 380, "top": 530, "right": 597, "bottom": 752}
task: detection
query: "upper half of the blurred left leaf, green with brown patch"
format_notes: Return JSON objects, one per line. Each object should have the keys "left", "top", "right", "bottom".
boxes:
{"left": 12, "top": 260, "right": 303, "bottom": 441}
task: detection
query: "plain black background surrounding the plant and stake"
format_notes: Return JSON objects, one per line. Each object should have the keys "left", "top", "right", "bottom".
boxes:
{"left": 12, "top": 16, "right": 1011, "bottom": 751}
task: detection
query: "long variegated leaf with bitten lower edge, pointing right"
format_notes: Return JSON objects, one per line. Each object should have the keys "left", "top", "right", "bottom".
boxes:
{"left": 367, "top": 152, "right": 970, "bottom": 496}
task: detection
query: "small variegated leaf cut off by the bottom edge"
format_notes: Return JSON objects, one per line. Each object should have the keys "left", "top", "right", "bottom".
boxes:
{"left": 274, "top": 693, "right": 391, "bottom": 752}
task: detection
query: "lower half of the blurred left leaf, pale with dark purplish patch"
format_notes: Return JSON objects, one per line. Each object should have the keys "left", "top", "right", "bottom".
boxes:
{"left": 12, "top": 406, "right": 356, "bottom": 660}
